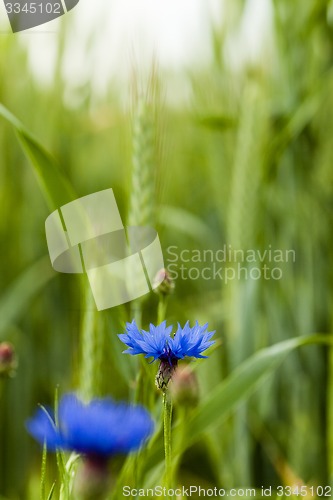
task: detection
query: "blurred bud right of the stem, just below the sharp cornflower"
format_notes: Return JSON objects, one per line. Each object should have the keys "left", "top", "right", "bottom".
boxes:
{"left": 170, "top": 366, "right": 199, "bottom": 407}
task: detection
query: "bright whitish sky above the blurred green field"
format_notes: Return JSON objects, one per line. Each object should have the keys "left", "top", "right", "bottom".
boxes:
{"left": 0, "top": 0, "right": 270, "bottom": 100}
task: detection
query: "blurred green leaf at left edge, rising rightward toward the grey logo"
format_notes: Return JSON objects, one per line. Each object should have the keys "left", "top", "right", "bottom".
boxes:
{"left": 0, "top": 256, "right": 56, "bottom": 339}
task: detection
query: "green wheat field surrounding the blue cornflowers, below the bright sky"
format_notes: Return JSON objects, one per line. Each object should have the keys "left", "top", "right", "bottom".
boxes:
{"left": 0, "top": 0, "right": 333, "bottom": 500}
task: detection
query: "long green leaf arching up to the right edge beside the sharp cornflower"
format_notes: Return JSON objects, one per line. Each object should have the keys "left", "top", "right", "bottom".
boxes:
{"left": 147, "top": 334, "right": 333, "bottom": 469}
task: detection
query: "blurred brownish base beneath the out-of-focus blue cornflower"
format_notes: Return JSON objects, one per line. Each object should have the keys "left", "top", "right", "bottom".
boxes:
{"left": 74, "top": 456, "right": 110, "bottom": 500}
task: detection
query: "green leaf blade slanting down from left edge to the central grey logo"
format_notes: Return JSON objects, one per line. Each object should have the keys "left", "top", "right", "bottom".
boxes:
{"left": 0, "top": 104, "right": 77, "bottom": 211}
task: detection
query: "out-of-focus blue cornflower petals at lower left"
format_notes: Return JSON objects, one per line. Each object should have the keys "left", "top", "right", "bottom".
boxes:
{"left": 26, "top": 394, "right": 153, "bottom": 460}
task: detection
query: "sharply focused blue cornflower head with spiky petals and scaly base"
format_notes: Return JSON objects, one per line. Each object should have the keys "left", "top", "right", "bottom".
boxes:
{"left": 118, "top": 320, "right": 215, "bottom": 392}
